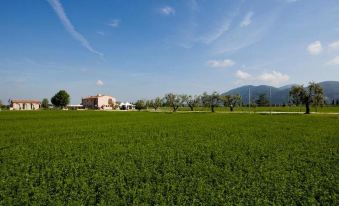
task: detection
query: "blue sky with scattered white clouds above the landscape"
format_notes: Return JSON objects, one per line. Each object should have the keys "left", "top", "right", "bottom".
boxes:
{"left": 0, "top": 0, "right": 339, "bottom": 103}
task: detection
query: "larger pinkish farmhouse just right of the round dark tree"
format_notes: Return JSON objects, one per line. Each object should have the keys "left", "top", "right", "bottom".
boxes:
{"left": 81, "top": 94, "right": 116, "bottom": 110}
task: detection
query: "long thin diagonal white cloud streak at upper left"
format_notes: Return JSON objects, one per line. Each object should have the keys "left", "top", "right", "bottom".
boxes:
{"left": 48, "top": 0, "right": 103, "bottom": 56}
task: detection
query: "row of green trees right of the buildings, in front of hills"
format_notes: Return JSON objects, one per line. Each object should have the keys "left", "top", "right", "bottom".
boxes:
{"left": 135, "top": 82, "right": 325, "bottom": 114}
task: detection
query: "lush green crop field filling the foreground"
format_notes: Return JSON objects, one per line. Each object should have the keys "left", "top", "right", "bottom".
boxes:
{"left": 0, "top": 111, "right": 339, "bottom": 205}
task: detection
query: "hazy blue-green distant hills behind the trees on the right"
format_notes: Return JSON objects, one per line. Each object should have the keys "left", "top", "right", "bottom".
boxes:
{"left": 224, "top": 81, "right": 339, "bottom": 104}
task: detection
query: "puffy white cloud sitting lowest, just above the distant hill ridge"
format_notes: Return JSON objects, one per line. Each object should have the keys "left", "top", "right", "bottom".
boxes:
{"left": 235, "top": 70, "right": 290, "bottom": 85}
